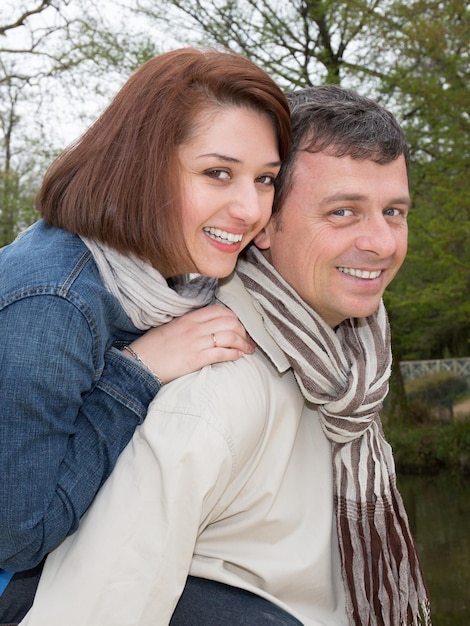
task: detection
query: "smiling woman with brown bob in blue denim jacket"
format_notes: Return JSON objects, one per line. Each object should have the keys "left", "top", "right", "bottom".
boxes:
{"left": 0, "top": 49, "right": 290, "bottom": 623}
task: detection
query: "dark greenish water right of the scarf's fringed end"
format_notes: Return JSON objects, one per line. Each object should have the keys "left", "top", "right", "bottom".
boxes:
{"left": 398, "top": 474, "right": 470, "bottom": 626}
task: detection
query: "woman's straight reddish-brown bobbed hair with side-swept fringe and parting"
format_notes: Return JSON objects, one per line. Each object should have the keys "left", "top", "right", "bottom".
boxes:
{"left": 36, "top": 48, "right": 291, "bottom": 276}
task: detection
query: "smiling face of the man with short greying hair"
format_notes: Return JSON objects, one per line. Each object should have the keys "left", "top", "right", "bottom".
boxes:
{"left": 256, "top": 152, "right": 410, "bottom": 328}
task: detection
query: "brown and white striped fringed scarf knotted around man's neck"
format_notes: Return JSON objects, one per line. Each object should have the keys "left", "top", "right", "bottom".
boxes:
{"left": 237, "top": 247, "right": 431, "bottom": 626}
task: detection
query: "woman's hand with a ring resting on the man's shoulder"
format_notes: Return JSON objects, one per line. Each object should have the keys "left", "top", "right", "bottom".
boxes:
{"left": 121, "top": 304, "right": 255, "bottom": 383}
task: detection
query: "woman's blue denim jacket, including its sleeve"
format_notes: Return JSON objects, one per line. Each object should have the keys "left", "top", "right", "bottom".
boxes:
{"left": 0, "top": 221, "right": 159, "bottom": 571}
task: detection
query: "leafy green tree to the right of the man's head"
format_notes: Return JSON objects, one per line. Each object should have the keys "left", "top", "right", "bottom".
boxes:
{"left": 383, "top": 0, "right": 470, "bottom": 359}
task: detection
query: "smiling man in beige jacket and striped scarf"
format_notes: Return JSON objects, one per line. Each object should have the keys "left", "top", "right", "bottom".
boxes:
{"left": 20, "top": 86, "right": 431, "bottom": 626}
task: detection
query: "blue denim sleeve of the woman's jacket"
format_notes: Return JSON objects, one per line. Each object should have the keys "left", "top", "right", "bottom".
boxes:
{"left": 0, "top": 295, "right": 159, "bottom": 571}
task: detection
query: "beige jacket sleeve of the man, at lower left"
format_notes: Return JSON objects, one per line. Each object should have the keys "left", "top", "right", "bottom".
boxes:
{"left": 22, "top": 380, "right": 232, "bottom": 626}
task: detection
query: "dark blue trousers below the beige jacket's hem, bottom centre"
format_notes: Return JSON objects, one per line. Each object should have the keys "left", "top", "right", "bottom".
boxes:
{"left": 170, "top": 576, "right": 302, "bottom": 626}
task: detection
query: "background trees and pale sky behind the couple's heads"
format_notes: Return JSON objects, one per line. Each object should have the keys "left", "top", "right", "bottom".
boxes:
{"left": 0, "top": 0, "right": 470, "bottom": 366}
